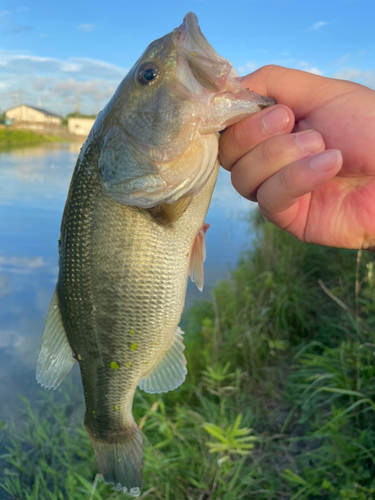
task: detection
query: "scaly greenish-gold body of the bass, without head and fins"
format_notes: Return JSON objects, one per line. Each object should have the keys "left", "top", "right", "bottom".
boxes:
{"left": 58, "top": 141, "right": 215, "bottom": 437}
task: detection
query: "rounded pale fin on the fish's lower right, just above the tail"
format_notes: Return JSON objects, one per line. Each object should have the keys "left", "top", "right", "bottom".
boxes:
{"left": 138, "top": 327, "right": 187, "bottom": 392}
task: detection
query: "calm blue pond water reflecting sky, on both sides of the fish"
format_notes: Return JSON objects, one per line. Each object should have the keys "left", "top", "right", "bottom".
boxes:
{"left": 0, "top": 144, "right": 251, "bottom": 420}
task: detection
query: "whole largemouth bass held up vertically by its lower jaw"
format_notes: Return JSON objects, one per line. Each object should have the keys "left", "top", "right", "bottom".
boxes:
{"left": 37, "top": 13, "right": 274, "bottom": 496}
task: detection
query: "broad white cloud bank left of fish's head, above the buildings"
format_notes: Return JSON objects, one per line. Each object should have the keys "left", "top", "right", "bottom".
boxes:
{"left": 0, "top": 49, "right": 128, "bottom": 115}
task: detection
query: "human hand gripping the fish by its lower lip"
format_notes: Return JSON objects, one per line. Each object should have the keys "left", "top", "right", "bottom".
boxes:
{"left": 219, "top": 66, "right": 375, "bottom": 249}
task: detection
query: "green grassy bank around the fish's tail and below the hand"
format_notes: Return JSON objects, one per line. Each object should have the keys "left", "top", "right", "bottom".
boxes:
{"left": 0, "top": 212, "right": 375, "bottom": 500}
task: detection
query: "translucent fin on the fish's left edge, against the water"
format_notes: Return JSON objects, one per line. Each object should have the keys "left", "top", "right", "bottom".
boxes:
{"left": 36, "top": 291, "right": 75, "bottom": 389}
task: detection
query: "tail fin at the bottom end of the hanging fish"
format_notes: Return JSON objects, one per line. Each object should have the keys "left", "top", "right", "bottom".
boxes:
{"left": 86, "top": 420, "right": 143, "bottom": 497}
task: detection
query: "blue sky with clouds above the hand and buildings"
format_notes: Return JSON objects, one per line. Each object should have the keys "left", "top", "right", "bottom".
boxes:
{"left": 0, "top": 0, "right": 375, "bottom": 115}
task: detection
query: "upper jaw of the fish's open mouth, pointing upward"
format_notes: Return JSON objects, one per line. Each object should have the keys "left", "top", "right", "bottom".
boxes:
{"left": 173, "top": 12, "right": 238, "bottom": 92}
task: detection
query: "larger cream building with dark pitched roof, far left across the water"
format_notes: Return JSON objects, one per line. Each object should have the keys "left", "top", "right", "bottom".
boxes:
{"left": 5, "top": 104, "right": 62, "bottom": 129}
